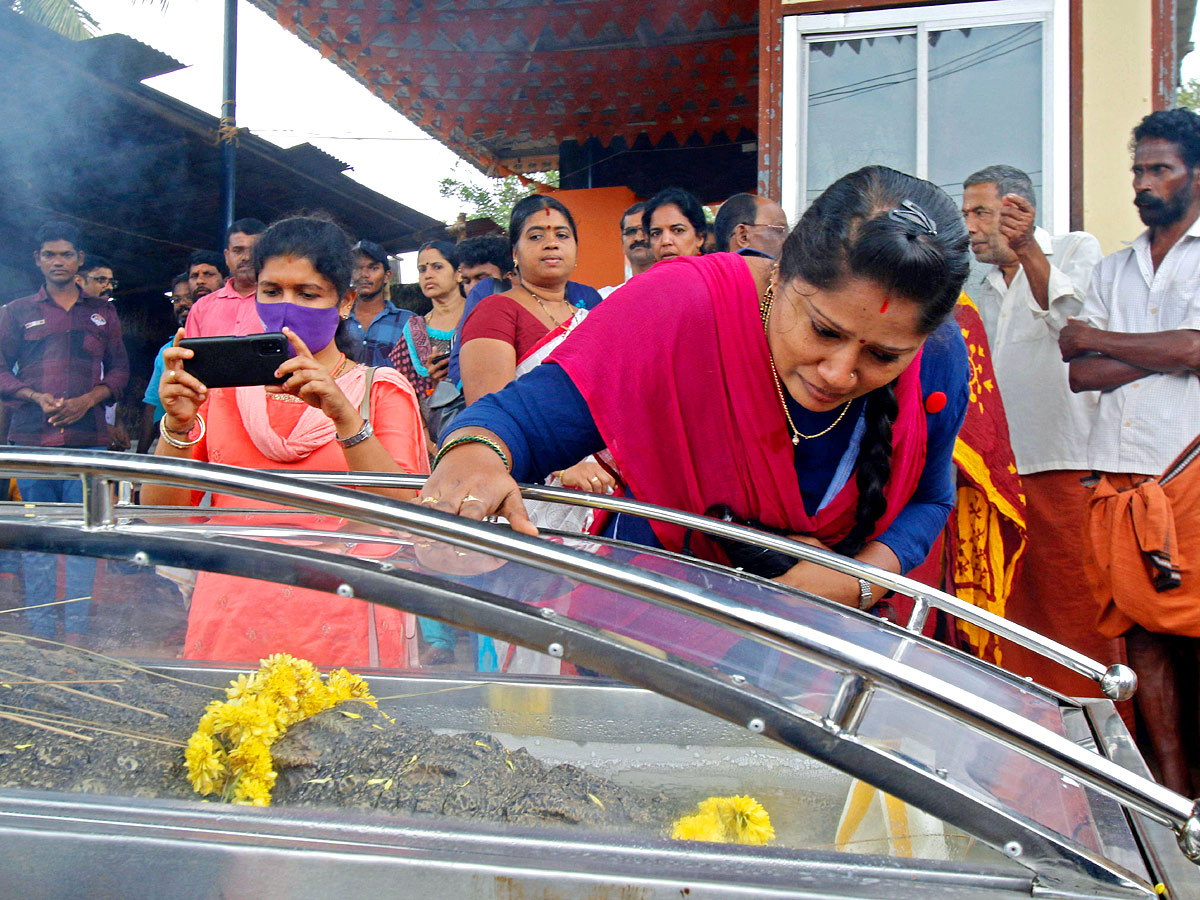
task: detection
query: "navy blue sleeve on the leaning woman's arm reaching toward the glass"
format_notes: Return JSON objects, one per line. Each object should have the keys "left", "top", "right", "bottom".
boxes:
{"left": 443, "top": 362, "right": 604, "bottom": 484}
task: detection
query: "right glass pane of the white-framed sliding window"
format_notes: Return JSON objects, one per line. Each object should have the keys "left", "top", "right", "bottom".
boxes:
{"left": 929, "top": 22, "right": 1043, "bottom": 210}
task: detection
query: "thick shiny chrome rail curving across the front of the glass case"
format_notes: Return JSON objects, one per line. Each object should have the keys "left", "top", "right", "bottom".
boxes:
{"left": 0, "top": 446, "right": 1200, "bottom": 883}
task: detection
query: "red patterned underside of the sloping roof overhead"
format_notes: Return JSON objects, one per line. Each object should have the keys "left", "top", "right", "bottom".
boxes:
{"left": 251, "top": 0, "right": 758, "bottom": 169}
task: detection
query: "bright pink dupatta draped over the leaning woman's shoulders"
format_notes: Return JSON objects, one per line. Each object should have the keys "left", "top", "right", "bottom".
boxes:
{"left": 550, "top": 253, "right": 928, "bottom": 558}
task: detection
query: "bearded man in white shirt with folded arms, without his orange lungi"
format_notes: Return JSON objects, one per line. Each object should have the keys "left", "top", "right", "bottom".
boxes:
{"left": 1058, "top": 109, "right": 1200, "bottom": 796}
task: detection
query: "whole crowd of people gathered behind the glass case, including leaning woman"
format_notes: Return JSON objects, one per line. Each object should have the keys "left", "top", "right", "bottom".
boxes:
{"left": 0, "top": 109, "right": 1200, "bottom": 796}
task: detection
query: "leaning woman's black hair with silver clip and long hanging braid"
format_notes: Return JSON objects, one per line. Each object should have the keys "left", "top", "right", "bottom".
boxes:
{"left": 779, "top": 166, "right": 971, "bottom": 556}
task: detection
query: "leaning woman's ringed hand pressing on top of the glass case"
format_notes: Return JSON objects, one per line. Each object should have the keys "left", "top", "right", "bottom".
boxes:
{"left": 416, "top": 432, "right": 538, "bottom": 534}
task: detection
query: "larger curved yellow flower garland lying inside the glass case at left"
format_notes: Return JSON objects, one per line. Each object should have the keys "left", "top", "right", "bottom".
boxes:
{"left": 184, "top": 653, "right": 376, "bottom": 806}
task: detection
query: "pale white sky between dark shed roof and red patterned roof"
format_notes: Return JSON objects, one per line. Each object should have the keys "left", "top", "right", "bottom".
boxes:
{"left": 80, "top": 0, "right": 490, "bottom": 221}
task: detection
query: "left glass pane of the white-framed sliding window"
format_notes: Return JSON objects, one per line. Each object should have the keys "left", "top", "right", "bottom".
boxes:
{"left": 804, "top": 32, "right": 917, "bottom": 206}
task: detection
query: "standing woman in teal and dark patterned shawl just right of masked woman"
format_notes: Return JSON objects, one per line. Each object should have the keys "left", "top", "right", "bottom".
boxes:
{"left": 389, "top": 241, "right": 466, "bottom": 440}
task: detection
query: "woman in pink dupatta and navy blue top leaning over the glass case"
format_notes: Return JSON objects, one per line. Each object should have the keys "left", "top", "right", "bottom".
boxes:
{"left": 421, "top": 167, "right": 970, "bottom": 608}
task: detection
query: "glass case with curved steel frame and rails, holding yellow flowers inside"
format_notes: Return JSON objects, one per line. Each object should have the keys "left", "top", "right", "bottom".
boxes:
{"left": 0, "top": 448, "right": 1200, "bottom": 900}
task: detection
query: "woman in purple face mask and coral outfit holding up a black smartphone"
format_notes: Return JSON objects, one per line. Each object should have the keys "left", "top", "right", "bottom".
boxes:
{"left": 142, "top": 216, "right": 428, "bottom": 666}
